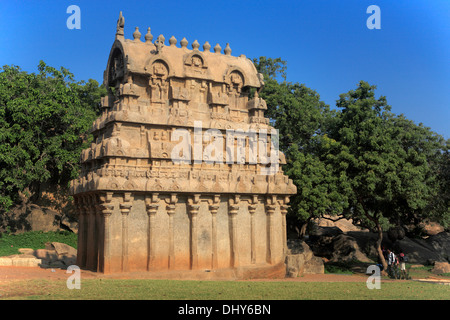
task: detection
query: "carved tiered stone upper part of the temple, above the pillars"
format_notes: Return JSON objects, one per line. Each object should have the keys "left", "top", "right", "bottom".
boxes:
{"left": 71, "top": 14, "right": 296, "bottom": 195}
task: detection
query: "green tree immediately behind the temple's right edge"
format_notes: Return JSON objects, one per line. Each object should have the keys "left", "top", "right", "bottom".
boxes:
{"left": 253, "top": 57, "right": 346, "bottom": 235}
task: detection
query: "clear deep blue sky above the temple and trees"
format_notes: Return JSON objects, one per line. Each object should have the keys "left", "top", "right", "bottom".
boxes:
{"left": 0, "top": 0, "right": 450, "bottom": 138}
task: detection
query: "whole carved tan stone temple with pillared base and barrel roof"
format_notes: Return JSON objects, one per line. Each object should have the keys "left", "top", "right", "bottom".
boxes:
{"left": 71, "top": 13, "right": 296, "bottom": 278}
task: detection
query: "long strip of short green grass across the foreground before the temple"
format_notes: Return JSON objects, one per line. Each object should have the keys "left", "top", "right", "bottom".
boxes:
{"left": 0, "top": 279, "right": 450, "bottom": 300}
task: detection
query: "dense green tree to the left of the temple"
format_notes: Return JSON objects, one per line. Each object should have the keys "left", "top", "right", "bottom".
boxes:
{"left": 0, "top": 61, "right": 106, "bottom": 210}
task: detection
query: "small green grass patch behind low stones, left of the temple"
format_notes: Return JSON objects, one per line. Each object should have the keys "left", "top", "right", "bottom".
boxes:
{"left": 0, "top": 231, "right": 77, "bottom": 257}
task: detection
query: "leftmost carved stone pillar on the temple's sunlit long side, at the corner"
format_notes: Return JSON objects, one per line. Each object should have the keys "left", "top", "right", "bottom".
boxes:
{"left": 99, "top": 192, "right": 114, "bottom": 273}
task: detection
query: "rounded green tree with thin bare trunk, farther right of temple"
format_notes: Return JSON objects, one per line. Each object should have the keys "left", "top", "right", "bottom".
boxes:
{"left": 328, "top": 81, "right": 443, "bottom": 267}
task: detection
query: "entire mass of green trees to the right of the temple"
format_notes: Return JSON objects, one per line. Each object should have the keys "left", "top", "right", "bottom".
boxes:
{"left": 253, "top": 57, "right": 450, "bottom": 264}
